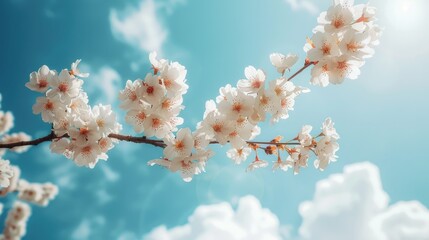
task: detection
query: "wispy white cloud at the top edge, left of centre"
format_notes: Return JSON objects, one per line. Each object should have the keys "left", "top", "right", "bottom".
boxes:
{"left": 110, "top": 0, "right": 168, "bottom": 52}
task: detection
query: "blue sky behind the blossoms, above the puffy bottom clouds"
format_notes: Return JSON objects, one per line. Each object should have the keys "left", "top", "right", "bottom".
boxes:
{"left": 0, "top": 0, "right": 429, "bottom": 239}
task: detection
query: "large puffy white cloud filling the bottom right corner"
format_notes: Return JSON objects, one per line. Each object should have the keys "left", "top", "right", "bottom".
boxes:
{"left": 299, "top": 163, "right": 429, "bottom": 240}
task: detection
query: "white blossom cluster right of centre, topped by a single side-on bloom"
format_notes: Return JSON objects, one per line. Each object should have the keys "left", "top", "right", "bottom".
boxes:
{"left": 201, "top": 53, "right": 310, "bottom": 157}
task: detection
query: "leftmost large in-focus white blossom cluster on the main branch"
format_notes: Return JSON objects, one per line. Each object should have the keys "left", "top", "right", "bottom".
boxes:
{"left": 26, "top": 60, "right": 122, "bottom": 168}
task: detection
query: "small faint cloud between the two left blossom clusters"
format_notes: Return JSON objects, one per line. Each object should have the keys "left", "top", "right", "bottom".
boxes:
{"left": 82, "top": 64, "right": 121, "bottom": 104}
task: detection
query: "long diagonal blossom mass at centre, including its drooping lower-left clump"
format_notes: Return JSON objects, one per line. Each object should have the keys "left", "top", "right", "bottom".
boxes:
{"left": 149, "top": 53, "right": 309, "bottom": 181}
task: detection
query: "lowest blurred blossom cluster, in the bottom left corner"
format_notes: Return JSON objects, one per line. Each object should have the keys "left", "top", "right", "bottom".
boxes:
{"left": 0, "top": 201, "right": 31, "bottom": 240}
